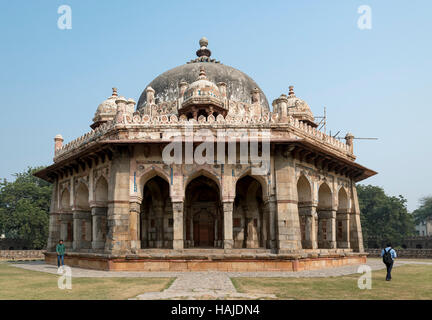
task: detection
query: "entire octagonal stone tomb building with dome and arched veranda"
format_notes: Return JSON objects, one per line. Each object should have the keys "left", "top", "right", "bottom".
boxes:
{"left": 36, "top": 38, "right": 376, "bottom": 271}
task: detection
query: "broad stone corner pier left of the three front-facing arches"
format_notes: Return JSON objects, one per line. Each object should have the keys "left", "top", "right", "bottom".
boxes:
{"left": 105, "top": 147, "right": 130, "bottom": 254}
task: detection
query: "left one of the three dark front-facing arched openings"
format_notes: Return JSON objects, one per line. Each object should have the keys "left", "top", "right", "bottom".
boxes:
{"left": 138, "top": 176, "right": 173, "bottom": 248}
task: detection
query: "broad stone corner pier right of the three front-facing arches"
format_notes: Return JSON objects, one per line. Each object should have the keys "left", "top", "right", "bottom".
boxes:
{"left": 275, "top": 150, "right": 302, "bottom": 252}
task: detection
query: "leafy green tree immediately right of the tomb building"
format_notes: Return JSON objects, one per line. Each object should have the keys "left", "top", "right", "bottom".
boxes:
{"left": 357, "top": 185, "right": 415, "bottom": 247}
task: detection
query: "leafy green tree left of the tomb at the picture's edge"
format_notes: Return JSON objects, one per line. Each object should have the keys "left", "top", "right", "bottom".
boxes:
{"left": 0, "top": 167, "right": 52, "bottom": 249}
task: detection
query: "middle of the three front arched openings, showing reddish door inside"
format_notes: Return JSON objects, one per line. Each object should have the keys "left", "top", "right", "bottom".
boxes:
{"left": 185, "top": 175, "right": 223, "bottom": 248}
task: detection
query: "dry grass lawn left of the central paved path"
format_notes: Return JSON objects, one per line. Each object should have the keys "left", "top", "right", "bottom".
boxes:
{"left": 0, "top": 262, "right": 173, "bottom": 300}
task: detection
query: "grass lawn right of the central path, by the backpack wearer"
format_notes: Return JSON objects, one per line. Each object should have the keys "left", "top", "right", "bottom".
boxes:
{"left": 232, "top": 265, "right": 432, "bottom": 300}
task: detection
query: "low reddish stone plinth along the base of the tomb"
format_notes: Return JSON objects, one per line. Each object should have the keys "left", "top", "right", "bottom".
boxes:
{"left": 44, "top": 249, "right": 367, "bottom": 272}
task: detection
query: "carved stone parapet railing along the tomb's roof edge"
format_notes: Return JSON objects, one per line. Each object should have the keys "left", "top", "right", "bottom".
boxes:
{"left": 55, "top": 113, "right": 350, "bottom": 158}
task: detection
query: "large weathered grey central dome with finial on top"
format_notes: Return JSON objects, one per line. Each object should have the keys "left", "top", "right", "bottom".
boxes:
{"left": 137, "top": 38, "right": 269, "bottom": 110}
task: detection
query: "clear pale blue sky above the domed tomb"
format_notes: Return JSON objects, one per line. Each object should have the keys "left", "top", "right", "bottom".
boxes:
{"left": 0, "top": 0, "right": 432, "bottom": 210}
